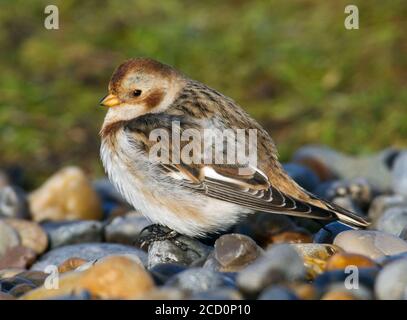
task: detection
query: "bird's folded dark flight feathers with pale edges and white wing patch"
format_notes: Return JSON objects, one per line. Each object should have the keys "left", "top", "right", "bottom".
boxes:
{"left": 163, "top": 165, "right": 335, "bottom": 219}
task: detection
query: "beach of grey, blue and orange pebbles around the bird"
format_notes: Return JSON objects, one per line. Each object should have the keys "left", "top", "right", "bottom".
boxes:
{"left": 0, "top": 146, "right": 407, "bottom": 300}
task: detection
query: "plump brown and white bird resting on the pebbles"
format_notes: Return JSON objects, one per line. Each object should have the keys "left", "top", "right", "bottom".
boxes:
{"left": 100, "top": 57, "right": 369, "bottom": 238}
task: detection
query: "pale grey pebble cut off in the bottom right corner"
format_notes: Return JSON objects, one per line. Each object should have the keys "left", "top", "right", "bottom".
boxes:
{"left": 375, "top": 259, "right": 407, "bottom": 300}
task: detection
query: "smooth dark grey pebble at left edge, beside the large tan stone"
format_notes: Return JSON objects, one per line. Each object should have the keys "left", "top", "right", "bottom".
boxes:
{"left": 0, "top": 185, "right": 30, "bottom": 219}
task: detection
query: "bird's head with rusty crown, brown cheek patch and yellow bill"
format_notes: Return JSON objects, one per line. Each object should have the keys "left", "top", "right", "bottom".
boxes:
{"left": 100, "top": 58, "right": 184, "bottom": 130}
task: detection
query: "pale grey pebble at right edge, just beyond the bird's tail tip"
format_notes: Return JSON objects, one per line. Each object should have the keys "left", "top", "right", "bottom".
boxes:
{"left": 375, "top": 206, "right": 407, "bottom": 236}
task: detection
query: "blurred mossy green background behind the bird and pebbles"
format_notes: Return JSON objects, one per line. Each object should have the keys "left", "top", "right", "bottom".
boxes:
{"left": 0, "top": 0, "right": 407, "bottom": 185}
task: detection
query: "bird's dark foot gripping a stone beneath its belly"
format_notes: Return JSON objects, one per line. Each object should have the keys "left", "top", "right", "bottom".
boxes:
{"left": 139, "top": 224, "right": 188, "bottom": 251}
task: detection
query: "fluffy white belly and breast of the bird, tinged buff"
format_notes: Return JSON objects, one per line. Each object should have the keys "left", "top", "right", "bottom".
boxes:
{"left": 101, "top": 131, "right": 251, "bottom": 237}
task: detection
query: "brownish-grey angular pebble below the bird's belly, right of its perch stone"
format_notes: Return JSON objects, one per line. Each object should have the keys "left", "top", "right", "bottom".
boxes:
{"left": 214, "top": 233, "right": 263, "bottom": 272}
